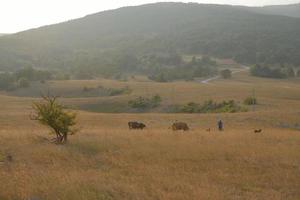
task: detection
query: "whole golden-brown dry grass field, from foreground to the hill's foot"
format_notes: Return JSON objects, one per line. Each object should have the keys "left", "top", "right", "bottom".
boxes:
{"left": 0, "top": 73, "right": 300, "bottom": 200}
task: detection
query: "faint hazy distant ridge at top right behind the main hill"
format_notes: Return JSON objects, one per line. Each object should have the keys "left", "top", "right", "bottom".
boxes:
{"left": 254, "top": 3, "right": 300, "bottom": 18}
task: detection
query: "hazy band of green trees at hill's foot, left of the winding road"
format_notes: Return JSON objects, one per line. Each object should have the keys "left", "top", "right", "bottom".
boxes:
{"left": 70, "top": 52, "right": 218, "bottom": 82}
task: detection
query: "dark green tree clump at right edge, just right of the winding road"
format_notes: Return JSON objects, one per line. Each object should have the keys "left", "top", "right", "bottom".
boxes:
{"left": 250, "top": 64, "right": 300, "bottom": 78}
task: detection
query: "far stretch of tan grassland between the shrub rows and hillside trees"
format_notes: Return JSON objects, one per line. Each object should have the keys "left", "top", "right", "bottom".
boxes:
{"left": 2, "top": 72, "right": 300, "bottom": 113}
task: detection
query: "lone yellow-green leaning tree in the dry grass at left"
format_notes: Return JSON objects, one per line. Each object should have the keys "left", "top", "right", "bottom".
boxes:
{"left": 31, "top": 95, "right": 76, "bottom": 144}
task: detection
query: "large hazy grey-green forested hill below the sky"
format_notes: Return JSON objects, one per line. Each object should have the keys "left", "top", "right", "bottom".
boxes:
{"left": 0, "top": 3, "right": 300, "bottom": 69}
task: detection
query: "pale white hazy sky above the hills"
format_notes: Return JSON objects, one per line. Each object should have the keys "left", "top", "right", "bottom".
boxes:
{"left": 0, "top": 0, "right": 300, "bottom": 33}
